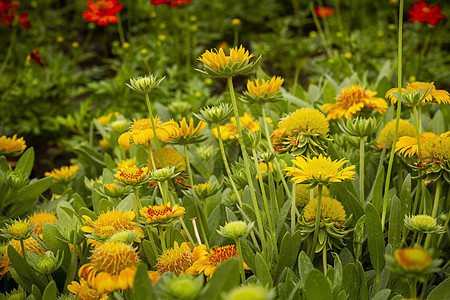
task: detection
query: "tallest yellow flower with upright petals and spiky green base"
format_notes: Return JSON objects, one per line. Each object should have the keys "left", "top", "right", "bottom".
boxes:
{"left": 197, "top": 45, "right": 261, "bottom": 77}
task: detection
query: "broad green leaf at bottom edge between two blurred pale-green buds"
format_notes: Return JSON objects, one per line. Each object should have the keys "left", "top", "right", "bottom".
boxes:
{"left": 199, "top": 258, "right": 240, "bottom": 300}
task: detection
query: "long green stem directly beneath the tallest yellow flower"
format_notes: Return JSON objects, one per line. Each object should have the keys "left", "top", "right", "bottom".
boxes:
{"left": 228, "top": 77, "right": 267, "bottom": 254}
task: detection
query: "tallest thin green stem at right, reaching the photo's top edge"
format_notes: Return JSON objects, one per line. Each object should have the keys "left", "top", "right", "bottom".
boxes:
{"left": 381, "top": 0, "right": 404, "bottom": 228}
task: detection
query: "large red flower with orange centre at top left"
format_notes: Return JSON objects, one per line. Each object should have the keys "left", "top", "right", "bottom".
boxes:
{"left": 83, "top": 0, "right": 123, "bottom": 26}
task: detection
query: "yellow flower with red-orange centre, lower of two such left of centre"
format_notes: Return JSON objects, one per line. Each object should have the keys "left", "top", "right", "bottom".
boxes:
{"left": 139, "top": 202, "right": 186, "bottom": 226}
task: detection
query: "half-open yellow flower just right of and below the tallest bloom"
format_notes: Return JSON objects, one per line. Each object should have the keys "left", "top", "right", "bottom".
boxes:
{"left": 241, "top": 76, "right": 284, "bottom": 104}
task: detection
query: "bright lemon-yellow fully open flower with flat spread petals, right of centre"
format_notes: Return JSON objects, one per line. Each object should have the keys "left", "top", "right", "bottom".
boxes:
{"left": 283, "top": 155, "right": 355, "bottom": 186}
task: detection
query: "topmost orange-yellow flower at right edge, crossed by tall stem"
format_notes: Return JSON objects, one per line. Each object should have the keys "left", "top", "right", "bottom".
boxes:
{"left": 385, "top": 81, "right": 450, "bottom": 105}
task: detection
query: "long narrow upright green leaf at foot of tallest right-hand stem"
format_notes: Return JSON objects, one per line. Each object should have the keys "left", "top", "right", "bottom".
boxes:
{"left": 366, "top": 203, "right": 385, "bottom": 274}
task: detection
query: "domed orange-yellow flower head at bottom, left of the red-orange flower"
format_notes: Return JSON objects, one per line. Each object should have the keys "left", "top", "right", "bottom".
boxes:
{"left": 149, "top": 241, "right": 206, "bottom": 284}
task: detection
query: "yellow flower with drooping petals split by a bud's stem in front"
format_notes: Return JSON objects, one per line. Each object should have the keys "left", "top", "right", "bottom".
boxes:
{"left": 118, "top": 118, "right": 180, "bottom": 148}
